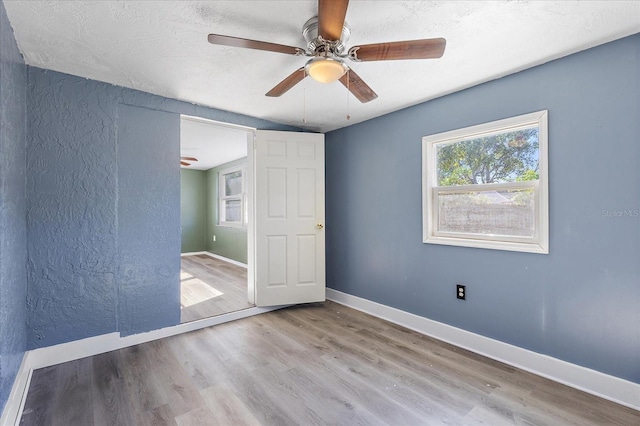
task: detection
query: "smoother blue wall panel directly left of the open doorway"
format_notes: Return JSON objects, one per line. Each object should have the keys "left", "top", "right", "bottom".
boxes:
{"left": 116, "top": 105, "right": 180, "bottom": 334}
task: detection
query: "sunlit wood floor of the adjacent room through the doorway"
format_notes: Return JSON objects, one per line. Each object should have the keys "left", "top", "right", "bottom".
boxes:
{"left": 180, "top": 254, "right": 254, "bottom": 323}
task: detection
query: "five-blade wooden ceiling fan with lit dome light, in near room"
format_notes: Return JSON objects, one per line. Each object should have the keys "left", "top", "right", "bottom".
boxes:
{"left": 208, "top": 0, "right": 446, "bottom": 103}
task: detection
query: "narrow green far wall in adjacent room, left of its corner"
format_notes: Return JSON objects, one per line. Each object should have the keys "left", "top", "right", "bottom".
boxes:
{"left": 180, "top": 168, "right": 209, "bottom": 253}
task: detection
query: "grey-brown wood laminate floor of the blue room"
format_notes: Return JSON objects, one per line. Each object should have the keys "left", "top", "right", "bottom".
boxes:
{"left": 21, "top": 302, "right": 640, "bottom": 426}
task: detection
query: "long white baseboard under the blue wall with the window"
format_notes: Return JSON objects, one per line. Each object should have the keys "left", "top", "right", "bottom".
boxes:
{"left": 326, "top": 288, "right": 640, "bottom": 410}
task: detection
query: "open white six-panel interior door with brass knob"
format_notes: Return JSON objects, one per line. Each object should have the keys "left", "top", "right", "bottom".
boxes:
{"left": 254, "top": 131, "right": 325, "bottom": 306}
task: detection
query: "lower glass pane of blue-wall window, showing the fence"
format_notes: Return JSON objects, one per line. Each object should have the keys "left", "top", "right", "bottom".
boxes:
{"left": 437, "top": 189, "right": 535, "bottom": 238}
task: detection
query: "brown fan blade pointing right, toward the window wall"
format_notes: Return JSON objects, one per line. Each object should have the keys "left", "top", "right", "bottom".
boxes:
{"left": 349, "top": 38, "right": 447, "bottom": 61}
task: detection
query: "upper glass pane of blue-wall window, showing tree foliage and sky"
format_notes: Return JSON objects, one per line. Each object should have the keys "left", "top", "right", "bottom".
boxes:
{"left": 436, "top": 126, "right": 539, "bottom": 186}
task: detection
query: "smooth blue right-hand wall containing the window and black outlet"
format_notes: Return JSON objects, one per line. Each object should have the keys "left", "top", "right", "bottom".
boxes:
{"left": 326, "top": 35, "right": 640, "bottom": 383}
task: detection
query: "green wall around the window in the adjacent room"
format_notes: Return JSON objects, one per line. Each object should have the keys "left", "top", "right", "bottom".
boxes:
{"left": 206, "top": 157, "right": 247, "bottom": 263}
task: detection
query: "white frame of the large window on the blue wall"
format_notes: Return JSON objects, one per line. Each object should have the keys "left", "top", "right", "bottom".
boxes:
{"left": 422, "top": 110, "right": 549, "bottom": 254}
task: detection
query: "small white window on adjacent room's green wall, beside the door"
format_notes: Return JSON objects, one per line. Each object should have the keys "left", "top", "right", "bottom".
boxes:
{"left": 218, "top": 165, "right": 247, "bottom": 227}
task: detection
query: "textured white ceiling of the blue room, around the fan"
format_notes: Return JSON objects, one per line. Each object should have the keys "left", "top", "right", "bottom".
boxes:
{"left": 4, "top": 0, "right": 640, "bottom": 132}
